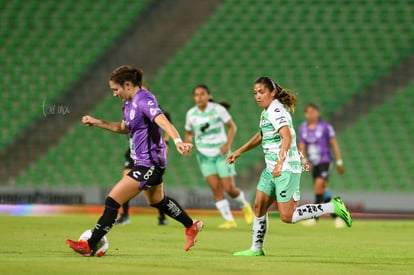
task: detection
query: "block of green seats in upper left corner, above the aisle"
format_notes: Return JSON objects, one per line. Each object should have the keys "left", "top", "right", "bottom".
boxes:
{"left": 0, "top": 0, "right": 149, "bottom": 149}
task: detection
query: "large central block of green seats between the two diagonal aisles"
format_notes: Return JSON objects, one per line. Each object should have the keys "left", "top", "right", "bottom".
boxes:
{"left": 9, "top": 0, "right": 414, "bottom": 193}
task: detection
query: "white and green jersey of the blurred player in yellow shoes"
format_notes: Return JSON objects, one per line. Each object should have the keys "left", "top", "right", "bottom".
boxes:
{"left": 185, "top": 102, "right": 231, "bottom": 157}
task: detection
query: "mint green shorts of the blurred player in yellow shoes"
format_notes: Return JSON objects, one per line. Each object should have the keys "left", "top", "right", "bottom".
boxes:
{"left": 197, "top": 153, "right": 236, "bottom": 178}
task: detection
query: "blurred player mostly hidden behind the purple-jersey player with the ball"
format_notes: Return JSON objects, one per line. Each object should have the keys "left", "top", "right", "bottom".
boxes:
{"left": 115, "top": 84, "right": 171, "bottom": 225}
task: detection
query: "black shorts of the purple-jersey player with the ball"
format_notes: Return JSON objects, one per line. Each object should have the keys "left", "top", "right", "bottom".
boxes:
{"left": 128, "top": 166, "right": 165, "bottom": 190}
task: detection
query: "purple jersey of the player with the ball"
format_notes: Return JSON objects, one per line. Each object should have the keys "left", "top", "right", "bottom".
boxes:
{"left": 122, "top": 89, "right": 167, "bottom": 168}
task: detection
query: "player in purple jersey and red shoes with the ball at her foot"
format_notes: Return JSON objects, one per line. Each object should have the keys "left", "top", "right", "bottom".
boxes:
{"left": 66, "top": 65, "right": 203, "bottom": 256}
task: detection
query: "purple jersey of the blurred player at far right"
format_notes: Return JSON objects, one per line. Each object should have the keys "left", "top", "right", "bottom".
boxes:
{"left": 299, "top": 120, "right": 335, "bottom": 166}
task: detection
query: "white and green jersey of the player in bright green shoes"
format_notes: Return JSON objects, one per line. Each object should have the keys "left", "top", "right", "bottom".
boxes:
{"left": 260, "top": 99, "right": 302, "bottom": 173}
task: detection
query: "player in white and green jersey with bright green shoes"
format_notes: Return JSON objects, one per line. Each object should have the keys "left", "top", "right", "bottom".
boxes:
{"left": 227, "top": 77, "right": 352, "bottom": 256}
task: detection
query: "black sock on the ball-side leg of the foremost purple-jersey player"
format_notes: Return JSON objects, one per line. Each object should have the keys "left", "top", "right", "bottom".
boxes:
{"left": 88, "top": 197, "right": 121, "bottom": 249}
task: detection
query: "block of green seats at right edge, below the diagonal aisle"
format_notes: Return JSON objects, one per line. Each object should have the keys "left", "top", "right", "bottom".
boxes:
{"left": 331, "top": 82, "right": 414, "bottom": 192}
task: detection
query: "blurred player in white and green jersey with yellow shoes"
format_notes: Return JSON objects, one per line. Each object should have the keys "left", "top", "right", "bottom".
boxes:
{"left": 185, "top": 85, "right": 253, "bottom": 229}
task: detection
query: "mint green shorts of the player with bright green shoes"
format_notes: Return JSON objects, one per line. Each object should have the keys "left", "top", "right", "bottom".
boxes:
{"left": 257, "top": 169, "right": 301, "bottom": 202}
